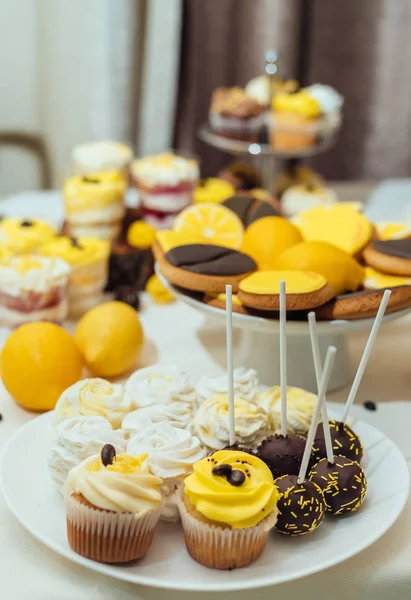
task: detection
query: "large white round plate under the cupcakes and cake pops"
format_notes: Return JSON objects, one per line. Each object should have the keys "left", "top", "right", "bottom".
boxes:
{"left": 0, "top": 405, "right": 409, "bottom": 591}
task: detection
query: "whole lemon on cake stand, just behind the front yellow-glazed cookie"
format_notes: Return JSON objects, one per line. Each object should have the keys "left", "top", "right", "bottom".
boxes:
{"left": 276, "top": 242, "right": 364, "bottom": 295}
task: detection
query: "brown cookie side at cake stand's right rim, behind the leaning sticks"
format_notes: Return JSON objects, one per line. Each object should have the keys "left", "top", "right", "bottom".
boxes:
{"left": 315, "top": 285, "right": 411, "bottom": 321}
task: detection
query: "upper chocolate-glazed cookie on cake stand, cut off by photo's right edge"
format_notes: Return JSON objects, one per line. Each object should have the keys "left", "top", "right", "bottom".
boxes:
{"left": 363, "top": 238, "right": 411, "bottom": 276}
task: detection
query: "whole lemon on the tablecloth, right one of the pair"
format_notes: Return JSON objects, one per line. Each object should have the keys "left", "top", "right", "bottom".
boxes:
{"left": 74, "top": 302, "right": 144, "bottom": 377}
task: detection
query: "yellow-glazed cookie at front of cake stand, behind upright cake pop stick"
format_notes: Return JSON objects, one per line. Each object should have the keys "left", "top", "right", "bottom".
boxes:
{"left": 238, "top": 271, "right": 335, "bottom": 310}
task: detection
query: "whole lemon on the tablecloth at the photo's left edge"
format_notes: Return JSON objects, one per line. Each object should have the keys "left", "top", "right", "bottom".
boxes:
{"left": 0, "top": 323, "right": 84, "bottom": 411}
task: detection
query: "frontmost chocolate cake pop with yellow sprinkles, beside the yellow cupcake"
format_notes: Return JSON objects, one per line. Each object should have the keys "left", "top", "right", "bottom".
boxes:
{"left": 275, "top": 475, "right": 325, "bottom": 536}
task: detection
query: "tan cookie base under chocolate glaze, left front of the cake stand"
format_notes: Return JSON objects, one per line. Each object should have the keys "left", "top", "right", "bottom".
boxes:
{"left": 158, "top": 258, "right": 253, "bottom": 294}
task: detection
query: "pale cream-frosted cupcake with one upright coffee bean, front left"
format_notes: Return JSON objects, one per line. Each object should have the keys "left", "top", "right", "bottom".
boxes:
{"left": 65, "top": 444, "right": 163, "bottom": 563}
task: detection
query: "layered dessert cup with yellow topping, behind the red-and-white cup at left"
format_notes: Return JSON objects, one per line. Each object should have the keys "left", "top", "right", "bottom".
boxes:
{"left": 40, "top": 236, "right": 110, "bottom": 317}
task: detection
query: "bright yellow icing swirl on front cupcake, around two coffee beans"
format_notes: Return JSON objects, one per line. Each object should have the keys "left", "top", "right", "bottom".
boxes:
{"left": 184, "top": 450, "right": 279, "bottom": 529}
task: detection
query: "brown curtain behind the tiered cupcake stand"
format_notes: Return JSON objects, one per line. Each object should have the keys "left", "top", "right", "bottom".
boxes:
{"left": 175, "top": 0, "right": 411, "bottom": 179}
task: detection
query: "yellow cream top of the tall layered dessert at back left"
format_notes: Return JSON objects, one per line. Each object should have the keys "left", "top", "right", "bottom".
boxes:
{"left": 63, "top": 171, "right": 127, "bottom": 215}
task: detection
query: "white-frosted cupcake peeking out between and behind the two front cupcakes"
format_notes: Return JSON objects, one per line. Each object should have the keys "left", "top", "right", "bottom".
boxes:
{"left": 127, "top": 423, "right": 205, "bottom": 521}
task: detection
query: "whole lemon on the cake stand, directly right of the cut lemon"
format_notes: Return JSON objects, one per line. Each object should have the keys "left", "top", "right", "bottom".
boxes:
{"left": 241, "top": 217, "right": 303, "bottom": 271}
